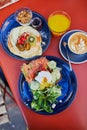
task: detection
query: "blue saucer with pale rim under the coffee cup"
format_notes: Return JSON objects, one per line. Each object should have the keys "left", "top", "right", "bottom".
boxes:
{"left": 59, "top": 30, "right": 87, "bottom": 64}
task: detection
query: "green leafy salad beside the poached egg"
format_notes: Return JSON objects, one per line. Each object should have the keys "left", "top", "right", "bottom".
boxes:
{"left": 31, "top": 86, "right": 61, "bottom": 113}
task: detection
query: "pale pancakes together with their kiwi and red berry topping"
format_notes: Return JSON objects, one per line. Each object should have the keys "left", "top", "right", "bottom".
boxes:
{"left": 8, "top": 26, "right": 42, "bottom": 58}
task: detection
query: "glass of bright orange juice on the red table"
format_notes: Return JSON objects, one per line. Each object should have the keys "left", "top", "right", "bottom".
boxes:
{"left": 48, "top": 11, "right": 71, "bottom": 36}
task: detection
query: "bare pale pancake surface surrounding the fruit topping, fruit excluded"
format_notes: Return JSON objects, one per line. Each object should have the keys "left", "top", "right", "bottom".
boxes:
{"left": 8, "top": 26, "right": 42, "bottom": 58}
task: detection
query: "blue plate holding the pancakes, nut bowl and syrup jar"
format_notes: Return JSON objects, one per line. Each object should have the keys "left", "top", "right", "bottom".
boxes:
{"left": 1, "top": 12, "right": 51, "bottom": 60}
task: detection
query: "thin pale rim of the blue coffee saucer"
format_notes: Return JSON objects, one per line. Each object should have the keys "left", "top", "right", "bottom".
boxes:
{"left": 59, "top": 29, "right": 87, "bottom": 64}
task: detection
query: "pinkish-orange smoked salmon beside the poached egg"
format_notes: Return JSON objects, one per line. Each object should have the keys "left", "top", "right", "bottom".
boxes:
{"left": 21, "top": 57, "right": 48, "bottom": 83}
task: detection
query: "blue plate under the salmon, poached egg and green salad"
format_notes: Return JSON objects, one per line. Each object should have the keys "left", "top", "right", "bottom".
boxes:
{"left": 18, "top": 56, "right": 77, "bottom": 115}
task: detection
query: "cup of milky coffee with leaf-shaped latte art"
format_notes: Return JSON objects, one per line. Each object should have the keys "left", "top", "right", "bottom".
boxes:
{"left": 68, "top": 32, "right": 87, "bottom": 54}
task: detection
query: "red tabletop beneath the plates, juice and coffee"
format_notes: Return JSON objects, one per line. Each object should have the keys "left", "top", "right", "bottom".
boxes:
{"left": 0, "top": 0, "right": 87, "bottom": 130}
